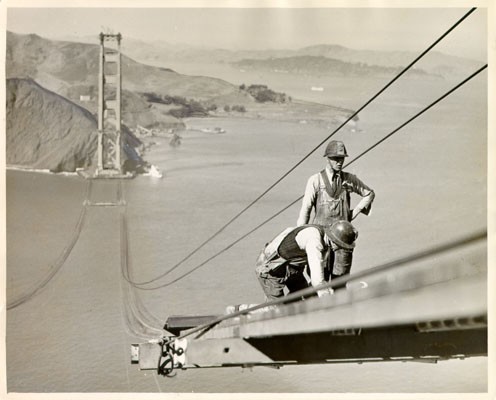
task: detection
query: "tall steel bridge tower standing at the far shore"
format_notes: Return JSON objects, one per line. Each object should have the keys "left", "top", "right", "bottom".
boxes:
{"left": 96, "top": 33, "right": 122, "bottom": 177}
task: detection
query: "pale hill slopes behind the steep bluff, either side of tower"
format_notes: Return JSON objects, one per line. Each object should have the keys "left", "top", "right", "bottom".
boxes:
{"left": 6, "top": 32, "right": 252, "bottom": 128}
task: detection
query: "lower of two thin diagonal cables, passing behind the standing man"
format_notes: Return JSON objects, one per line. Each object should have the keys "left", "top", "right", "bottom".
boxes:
{"left": 128, "top": 64, "right": 487, "bottom": 290}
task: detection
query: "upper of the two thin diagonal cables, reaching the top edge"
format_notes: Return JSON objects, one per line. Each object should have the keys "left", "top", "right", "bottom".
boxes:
{"left": 126, "top": 7, "right": 477, "bottom": 285}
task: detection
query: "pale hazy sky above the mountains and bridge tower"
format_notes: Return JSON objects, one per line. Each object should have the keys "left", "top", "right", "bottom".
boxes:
{"left": 3, "top": 1, "right": 487, "bottom": 61}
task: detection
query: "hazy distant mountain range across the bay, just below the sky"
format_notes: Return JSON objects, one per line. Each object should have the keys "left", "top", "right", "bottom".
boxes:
{"left": 107, "top": 38, "right": 481, "bottom": 78}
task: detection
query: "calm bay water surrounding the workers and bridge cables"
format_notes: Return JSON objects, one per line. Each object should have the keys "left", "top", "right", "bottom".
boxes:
{"left": 7, "top": 70, "right": 488, "bottom": 393}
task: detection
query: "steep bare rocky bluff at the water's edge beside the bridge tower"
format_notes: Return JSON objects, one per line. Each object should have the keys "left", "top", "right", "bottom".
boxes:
{"left": 6, "top": 78, "right": 143, "bottom": 172}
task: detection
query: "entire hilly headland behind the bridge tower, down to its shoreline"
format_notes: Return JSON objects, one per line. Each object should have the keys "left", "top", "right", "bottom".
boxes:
{"left": 6, "top": 32, "right": 360, "bottom": 171}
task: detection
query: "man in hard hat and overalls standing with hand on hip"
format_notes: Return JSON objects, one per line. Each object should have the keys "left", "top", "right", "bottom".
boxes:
{"left": 297, "top": 140, "right": 375, "bottom": 226}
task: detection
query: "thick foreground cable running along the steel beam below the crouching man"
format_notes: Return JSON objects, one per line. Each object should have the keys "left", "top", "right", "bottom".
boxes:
{"left": 172, "top": 230, "right": 487, "bottom": 339}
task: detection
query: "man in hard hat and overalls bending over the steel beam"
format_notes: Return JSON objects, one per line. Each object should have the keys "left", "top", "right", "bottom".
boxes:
{"left": 256, "top": 221, "right": 358, "bottom": 301}
